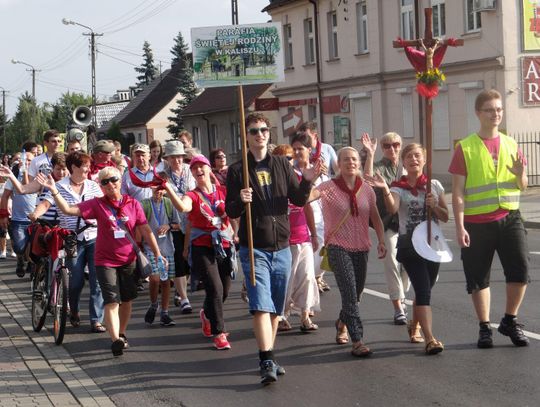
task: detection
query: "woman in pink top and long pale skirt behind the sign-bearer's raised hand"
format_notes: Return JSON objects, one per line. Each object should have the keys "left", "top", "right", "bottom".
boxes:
{"left": 272, "top": 145, "right": 321, "bottom": 333}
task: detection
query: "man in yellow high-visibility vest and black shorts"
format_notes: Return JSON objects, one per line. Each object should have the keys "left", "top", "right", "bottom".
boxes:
{"left": 448, "top": 89, "right": 529, "bottom": 348}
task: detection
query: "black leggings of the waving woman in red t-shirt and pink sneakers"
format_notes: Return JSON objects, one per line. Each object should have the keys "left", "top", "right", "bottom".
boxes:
{"left": 191, "top": 246, "right": 231, "bottom": 335}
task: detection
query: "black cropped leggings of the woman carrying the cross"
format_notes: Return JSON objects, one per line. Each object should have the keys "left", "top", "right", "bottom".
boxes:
{"left": 396, "top": 247, "right": 440, "bottom": 305}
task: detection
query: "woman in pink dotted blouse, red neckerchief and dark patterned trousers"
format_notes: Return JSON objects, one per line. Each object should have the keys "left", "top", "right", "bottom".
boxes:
{"left": 311, "top": 147, "right": 386, "bottom": 357}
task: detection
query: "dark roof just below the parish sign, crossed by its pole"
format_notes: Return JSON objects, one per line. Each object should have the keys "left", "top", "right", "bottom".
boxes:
{"left": 182, "top": 83, "right": 272, "bottom": 117}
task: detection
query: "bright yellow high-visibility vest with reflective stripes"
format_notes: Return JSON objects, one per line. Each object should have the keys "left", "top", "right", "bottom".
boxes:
{"left": 459, "top": 133, "right": 521, "bottom": 215}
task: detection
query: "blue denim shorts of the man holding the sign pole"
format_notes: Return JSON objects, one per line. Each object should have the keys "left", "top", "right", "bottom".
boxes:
{"left": 240, "top": 246, "right": 292, "bottom": 315}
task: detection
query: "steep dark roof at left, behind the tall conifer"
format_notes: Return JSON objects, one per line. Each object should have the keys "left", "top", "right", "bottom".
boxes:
{"left": 106, "top": 64, "right": 187, "bottom": 127}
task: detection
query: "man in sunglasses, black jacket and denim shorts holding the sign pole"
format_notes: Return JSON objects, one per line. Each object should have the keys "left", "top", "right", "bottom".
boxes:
{"left": 225, "top": 113, "right": 321, "bottom": 384}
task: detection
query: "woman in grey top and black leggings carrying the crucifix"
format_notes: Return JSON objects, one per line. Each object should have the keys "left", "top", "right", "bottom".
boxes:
{"left": 369, "top": 143, "right": 448, "bottom": 355}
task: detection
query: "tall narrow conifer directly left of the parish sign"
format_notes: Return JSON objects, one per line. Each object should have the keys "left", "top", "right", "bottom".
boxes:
{"left": 167, "top": 32, "right": 197, "bottom": 136}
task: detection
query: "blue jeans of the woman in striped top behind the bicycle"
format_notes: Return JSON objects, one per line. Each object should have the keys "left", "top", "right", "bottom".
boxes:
{"left": 66, "top": 239, "right": 103, "bottom": 324}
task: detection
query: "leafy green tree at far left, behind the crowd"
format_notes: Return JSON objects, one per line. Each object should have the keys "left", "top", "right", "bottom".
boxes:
{"left": 6, "top": 92, "right": 50, "bottom": 151}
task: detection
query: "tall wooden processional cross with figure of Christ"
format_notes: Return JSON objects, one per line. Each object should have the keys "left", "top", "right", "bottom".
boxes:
{"left": 393, "top": 8, "right": 463, "bottom": 243}
